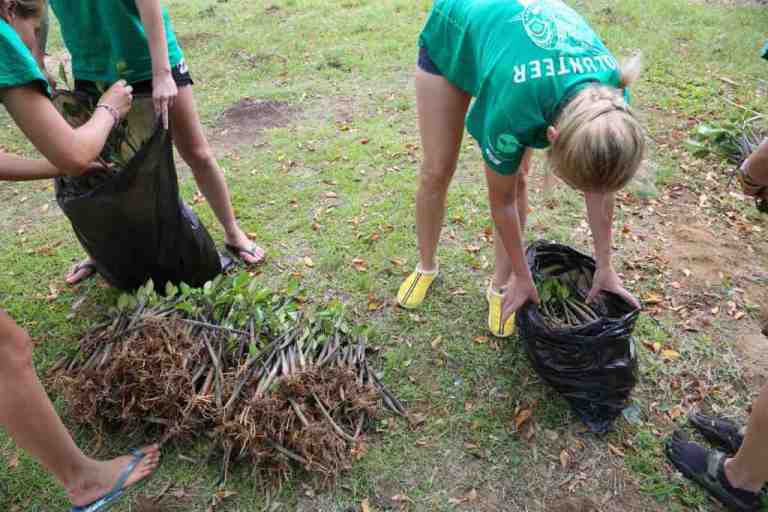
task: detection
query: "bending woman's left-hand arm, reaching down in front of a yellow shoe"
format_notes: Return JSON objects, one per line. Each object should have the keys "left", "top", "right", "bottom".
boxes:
{"left": 485, "top": 166, "right": 539, "bottom": 325}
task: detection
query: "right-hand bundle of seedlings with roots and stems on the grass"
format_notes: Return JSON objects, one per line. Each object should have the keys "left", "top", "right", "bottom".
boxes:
{"left": 217, "top": 321, "right": 405, "bottom": 480}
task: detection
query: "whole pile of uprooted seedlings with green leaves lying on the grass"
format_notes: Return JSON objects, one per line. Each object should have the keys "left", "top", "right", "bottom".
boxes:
{"left": 50, "top": 273, "right": 405, "bottom": 479}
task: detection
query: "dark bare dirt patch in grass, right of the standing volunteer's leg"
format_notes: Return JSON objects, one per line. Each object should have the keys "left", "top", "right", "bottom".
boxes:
{"left": 213, "top": 98, "right": 299, "bottom": 148}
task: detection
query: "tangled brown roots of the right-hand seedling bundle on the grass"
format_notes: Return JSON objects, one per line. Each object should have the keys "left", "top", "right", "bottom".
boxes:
{"left": 217, "top": 368, "right": 379, "bottom": 483}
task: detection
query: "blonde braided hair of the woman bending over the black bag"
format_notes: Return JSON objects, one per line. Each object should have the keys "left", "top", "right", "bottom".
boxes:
{"left": 549, "top": 55, "right": 645, "bottom": 192}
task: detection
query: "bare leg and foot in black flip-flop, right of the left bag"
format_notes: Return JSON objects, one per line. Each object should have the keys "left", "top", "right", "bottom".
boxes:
{"left": 169, "top": 86, "right": 264, "bottom": 263}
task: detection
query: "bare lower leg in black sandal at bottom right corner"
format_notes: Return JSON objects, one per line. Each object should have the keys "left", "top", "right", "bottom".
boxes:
{"left": 725, "top": 385, "right": 768, "bottom": 492}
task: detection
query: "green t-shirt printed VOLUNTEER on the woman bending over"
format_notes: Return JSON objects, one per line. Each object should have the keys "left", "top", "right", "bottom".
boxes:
{"left": 419, "top": 0, "right": 620, "bottom": 175}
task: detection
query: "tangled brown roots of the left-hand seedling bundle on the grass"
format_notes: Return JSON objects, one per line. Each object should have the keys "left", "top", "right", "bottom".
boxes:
{"left": 52, "top": 321, "right": 216, "bottom": 437}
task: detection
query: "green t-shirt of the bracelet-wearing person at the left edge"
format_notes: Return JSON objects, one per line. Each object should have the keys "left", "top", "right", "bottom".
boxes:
{"left": 0, "top": 20, "right": 51, "bottom": 96}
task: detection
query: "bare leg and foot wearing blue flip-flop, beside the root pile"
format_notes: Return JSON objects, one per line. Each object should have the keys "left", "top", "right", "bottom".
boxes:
{"left": 0, "top": 310, "right": 159, "bottom": 506}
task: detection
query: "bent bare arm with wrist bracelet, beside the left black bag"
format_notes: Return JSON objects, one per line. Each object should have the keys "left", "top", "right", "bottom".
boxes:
{"left": 0, "top": 81, "right": 132, "bottom": 177}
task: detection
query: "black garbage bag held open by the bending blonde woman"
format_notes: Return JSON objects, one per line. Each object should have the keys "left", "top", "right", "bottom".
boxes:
{"left": 516, "top": 241, "right": 640, "bottom": 433}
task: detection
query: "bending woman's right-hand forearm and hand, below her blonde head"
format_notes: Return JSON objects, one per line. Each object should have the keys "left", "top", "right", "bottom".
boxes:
{"left": 584, "top": 192, "right": 640, "bottom": 307}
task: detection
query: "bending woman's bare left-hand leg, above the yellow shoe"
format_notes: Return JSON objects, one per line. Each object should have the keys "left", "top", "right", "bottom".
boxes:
{"left": 416, "top": 69, "right": 472, "bottom": 271}
